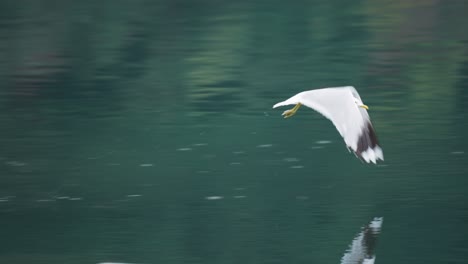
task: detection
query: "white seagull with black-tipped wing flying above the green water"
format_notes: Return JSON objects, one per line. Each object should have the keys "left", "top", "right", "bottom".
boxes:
{"left": 273, "top": 86, "right": 384, "bottom": 164}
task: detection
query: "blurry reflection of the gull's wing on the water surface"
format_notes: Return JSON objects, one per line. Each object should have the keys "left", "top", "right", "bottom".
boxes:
{"left": 341, "top": 217, "right": 383, "bottom": 264}
